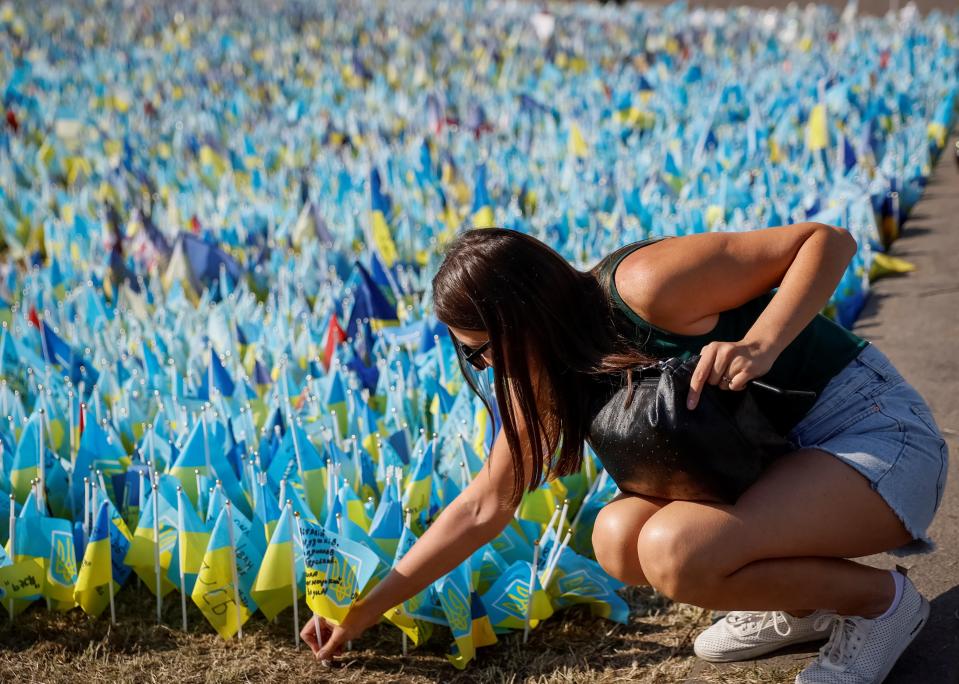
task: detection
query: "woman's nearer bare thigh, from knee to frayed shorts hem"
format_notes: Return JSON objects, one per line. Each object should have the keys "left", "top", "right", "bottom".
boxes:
{"left": 638, "top": 449, "right": 912, "bottom": 577}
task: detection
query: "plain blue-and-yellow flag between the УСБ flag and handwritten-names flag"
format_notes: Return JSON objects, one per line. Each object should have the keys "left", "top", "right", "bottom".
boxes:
{"left": 250, "top": 506, "right": 304, "bottom": 620}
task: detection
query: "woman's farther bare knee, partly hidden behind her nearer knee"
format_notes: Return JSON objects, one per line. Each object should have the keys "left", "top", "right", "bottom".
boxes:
{"left": 593, "top": 493, "right": 671, "bottom": 585}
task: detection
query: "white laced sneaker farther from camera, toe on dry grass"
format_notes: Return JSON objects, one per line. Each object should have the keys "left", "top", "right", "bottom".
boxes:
{"left": 693, "top": 610, "right": 836, "bottom": 663}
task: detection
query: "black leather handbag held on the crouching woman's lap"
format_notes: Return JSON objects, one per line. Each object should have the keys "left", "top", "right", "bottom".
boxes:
{"left": 587, "top": 356, "right": 815, "bottom": 503}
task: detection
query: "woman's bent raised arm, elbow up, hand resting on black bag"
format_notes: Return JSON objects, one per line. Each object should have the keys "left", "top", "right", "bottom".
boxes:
{"left": 616, "top": 223, "right": 856, "bottom": 408}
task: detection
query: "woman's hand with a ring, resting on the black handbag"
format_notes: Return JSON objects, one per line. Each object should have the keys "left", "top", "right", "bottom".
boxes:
{"left": 686, "top": 339, "right": 779, "bottom": 410}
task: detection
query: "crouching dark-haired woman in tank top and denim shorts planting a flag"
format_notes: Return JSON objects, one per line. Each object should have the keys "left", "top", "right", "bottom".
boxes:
{"left": 304, "top": 223, "right": 947, "bottom": 682}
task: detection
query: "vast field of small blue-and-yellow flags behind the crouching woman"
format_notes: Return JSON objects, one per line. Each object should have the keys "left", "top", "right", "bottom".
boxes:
{"left": 0, "top": 0, "right": 959, "bottom": 681}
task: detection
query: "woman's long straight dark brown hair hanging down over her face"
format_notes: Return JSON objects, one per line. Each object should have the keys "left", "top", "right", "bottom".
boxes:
{"left": 432, "top": 228, "right": 652, "bottom": 505}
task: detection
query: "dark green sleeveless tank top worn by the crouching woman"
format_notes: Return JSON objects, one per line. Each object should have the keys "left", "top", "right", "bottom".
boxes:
{"left": 603, "top": 238, "right": 869, "bottom": 433}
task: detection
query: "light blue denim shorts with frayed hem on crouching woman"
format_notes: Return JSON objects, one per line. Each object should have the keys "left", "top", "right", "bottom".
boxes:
{"left": 788, "top": 344, "right": 949, "bottom": 555}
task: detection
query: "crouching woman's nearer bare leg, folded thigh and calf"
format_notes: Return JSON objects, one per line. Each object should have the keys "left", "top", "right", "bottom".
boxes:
{"left": 628, "top": 449, "right": 912, "bottom": 617}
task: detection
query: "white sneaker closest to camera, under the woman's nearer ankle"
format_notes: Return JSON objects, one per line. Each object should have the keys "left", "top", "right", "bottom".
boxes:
{"left": 796, "top": 577, "right": 929, "bottom": 684}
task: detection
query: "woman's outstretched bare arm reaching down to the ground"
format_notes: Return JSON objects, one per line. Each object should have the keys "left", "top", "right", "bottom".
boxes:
{"left": 302, "top": 396, "right": 544, "bottom": 661}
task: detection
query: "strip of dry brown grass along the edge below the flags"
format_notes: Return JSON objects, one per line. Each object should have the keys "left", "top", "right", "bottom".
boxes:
{"left": 0, "top": 586, "right": 798, "bottom": 684}
